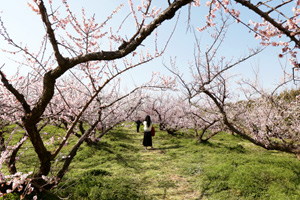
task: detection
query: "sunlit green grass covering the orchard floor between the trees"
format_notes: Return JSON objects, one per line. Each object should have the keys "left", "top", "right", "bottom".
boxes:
{"left": 2, "top": 124, "right": 300, "bottom": 200}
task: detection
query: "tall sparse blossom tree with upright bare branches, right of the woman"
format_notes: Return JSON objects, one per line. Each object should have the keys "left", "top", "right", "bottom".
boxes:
{"left": 167, "top": 18, "right": 261, "bottom": 142}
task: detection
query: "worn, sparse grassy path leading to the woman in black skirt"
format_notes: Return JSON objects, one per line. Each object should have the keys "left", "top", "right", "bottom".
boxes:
{"left": 131, "top": 126, "right": 200, "bottom": 200}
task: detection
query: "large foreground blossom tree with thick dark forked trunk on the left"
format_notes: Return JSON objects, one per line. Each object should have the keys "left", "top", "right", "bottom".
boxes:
{"left": 0, "top": 0, "right": 192, "bottom": 194}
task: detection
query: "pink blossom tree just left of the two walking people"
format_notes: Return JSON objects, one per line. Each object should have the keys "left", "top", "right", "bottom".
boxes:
{"left": 70, "top": 79, "right": 144, "bottom": 144}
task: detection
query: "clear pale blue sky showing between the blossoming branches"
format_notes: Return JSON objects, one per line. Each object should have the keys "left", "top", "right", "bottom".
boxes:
{"left": 0, "top": 0, "right": 297, "bottom": 97}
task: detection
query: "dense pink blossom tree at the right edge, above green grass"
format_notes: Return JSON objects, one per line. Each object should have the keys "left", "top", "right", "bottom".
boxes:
{"left": 231, "top": 78, "right": 300, "bottom": 159}
